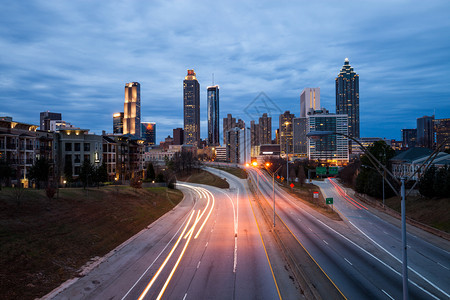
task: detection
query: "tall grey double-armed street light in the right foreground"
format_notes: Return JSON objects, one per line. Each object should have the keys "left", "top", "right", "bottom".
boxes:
{"left": 306, "top": 131, "right": 449, "bottom": 299}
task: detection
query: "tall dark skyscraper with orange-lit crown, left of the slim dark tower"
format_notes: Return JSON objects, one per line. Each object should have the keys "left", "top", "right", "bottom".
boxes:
{"left": 183, "top": 70, "right": 200, "bottom": 146}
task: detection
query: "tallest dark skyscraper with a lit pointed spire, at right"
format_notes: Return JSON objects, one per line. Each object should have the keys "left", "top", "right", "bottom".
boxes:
{"left": 336, "top": 58, "right": 359, "bottom": 138}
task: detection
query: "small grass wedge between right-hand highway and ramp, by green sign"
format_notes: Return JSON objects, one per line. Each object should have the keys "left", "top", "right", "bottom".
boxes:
{"left": 282, "top": 183, "right": 342, "bottom": 221}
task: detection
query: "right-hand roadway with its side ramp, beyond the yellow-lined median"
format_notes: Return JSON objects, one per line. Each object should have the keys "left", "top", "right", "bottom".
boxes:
{"left": 250, "top": 169, "right": 450, "bottom": 299}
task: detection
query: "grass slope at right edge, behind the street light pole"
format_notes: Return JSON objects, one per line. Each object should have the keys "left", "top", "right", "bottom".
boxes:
{"left": 380, "top": 196, "right": 450, "bottom": 233}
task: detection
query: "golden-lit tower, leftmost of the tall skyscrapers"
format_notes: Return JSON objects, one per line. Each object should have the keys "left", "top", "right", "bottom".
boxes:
{"left": 123, "top": 82, "right": 141, "bottom": 137}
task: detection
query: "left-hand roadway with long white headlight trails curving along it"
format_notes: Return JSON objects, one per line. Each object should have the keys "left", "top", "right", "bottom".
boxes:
{"left": 49, "top": 180, "right": 280, "bottom": 300}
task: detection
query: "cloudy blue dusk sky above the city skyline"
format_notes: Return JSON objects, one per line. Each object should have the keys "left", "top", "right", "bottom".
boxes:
{"left": 0, "top": 0, "right": 450, "bottom": 141}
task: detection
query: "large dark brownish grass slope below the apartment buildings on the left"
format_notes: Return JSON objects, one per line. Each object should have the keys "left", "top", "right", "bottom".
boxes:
{"left": 0, "top": 186, "right": 183, "bottom": 299}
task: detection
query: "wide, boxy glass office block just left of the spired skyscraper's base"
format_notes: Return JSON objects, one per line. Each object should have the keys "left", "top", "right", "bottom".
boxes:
{"left": 306, "top": 111, "right": 349, "bottom": 165}
